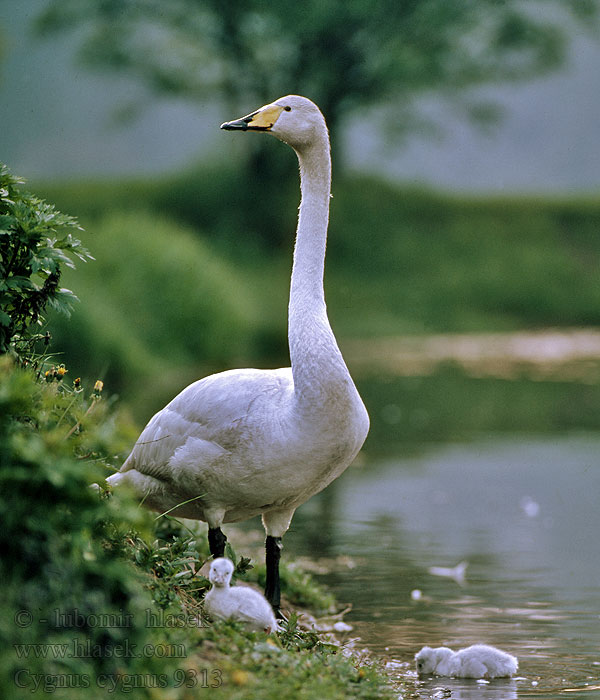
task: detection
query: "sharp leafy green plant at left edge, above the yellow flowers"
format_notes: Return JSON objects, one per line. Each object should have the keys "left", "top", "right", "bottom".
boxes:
{"left": 0, "top": 164, "right": 91, "bottom": 362}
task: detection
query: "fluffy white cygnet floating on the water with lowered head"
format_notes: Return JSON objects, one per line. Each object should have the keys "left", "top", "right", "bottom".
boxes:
{"left": 415, "top": 644, "right": 519, "bottom": 679}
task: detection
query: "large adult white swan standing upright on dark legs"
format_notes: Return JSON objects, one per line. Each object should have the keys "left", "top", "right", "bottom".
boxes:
{"left": 107, "top": 95, "right": 369, "bottom": 611}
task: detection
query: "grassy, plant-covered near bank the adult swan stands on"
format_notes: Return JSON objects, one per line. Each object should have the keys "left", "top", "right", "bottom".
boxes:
{"left": 0, "top": 357, "right": 394, "bottom": 700}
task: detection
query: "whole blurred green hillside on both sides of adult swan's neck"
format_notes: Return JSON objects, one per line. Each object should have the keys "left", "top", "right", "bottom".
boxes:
{"left": 37, "top": 168, "right": 600, "bottom": 412}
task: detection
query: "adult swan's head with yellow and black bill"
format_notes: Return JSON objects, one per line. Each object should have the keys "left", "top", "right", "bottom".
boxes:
{"left": 221, "top": 95, "right": 327, "bottom": 150}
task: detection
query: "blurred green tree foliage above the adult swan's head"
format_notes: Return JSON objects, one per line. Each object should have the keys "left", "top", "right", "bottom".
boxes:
{"left": 37, "top": 0, "right": 598, "bottom": 148}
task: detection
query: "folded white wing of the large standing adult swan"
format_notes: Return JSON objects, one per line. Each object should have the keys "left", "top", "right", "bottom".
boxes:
{"left": 121, "top": 369, "right": 291, "bottom": 479}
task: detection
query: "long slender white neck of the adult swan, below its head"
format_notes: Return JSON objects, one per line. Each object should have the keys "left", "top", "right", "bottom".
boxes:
{"left": 288, "top": 126, "right": 351, "bottom": 407}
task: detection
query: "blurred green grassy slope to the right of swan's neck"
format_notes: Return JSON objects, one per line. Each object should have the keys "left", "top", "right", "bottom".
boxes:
{"left": 328, "top": 179, "right": 600, "bottom": 336}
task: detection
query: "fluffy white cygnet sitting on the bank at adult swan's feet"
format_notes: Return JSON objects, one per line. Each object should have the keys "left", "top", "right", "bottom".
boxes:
{"left": 204, "top": 557, "right": 278, "bottom": 634}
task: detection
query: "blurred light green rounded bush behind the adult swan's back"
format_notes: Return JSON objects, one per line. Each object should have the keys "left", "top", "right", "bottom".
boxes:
{"left": 46, "top": 212, "right": 254, "bottom": 408}
